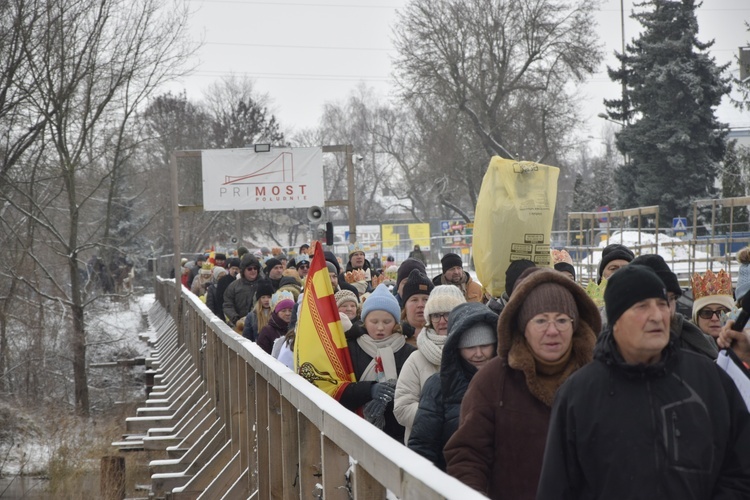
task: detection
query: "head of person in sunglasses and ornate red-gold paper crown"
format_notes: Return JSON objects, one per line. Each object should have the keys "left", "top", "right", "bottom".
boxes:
{"left": 690, "top": 269, "right": 734, "bottom": 340}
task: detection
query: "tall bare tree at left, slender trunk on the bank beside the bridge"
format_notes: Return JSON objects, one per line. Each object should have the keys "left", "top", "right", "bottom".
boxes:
{"left": 4, "top": 0, "right": 197, "bottom": 414}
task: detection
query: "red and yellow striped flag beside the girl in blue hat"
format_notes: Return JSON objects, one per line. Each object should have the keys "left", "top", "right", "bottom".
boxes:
{"left": 294, "top": 241, "right": 356, "bottom": 400}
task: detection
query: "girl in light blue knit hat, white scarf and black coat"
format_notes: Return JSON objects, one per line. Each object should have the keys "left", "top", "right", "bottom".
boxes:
{"left": 340, "top": 284, "right": 415, "bottom": 443}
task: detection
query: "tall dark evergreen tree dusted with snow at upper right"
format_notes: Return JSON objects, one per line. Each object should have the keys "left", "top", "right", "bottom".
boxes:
{"left": 604, "top": 0, "right": 730, "bottom": 223}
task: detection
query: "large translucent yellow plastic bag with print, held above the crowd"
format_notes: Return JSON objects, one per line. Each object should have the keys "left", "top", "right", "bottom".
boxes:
{"left": 473, "top": 156, "right": 560, "bottom": 297}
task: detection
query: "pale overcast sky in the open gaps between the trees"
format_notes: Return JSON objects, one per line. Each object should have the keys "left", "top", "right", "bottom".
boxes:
{"left": 171, "top": 0, "right": 750, "bottom": 145}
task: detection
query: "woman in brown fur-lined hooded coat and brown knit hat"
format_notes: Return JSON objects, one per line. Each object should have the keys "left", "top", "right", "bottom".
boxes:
{"left": 444, "top": 268, "right": 601, "bottom": 500}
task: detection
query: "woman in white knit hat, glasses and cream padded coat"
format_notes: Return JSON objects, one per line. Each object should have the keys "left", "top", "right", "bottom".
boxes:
{"left": 393, "top": 285, "right": 466, "bottom": 444}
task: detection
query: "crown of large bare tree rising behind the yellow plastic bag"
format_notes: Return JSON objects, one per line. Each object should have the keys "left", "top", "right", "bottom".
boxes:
{"left": 395, "top": 0, "right": 601, "bottom": 160}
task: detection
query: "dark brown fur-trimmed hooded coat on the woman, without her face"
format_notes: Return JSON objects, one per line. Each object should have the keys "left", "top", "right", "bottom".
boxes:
{"left": 444, "top": 269, "right": 601, "bottom": 500}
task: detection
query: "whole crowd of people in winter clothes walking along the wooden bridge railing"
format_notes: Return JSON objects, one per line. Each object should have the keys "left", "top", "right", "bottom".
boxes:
{"left": 182, "top": 244, "right": 750, "bottom": 500}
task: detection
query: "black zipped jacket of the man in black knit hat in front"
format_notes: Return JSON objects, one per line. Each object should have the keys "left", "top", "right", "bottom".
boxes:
{"left": 537, "top": 329, "right": 750, "bottom": 500}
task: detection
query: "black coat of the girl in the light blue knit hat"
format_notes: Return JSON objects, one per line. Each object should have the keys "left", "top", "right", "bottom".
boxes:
{"left": 339, "top": 324, "right": 417, "bottom": 443}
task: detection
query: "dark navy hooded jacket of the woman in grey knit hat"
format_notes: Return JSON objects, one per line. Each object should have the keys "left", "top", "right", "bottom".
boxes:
{"left": 408, "top": 303, "right": 497, "bottom": 470}
